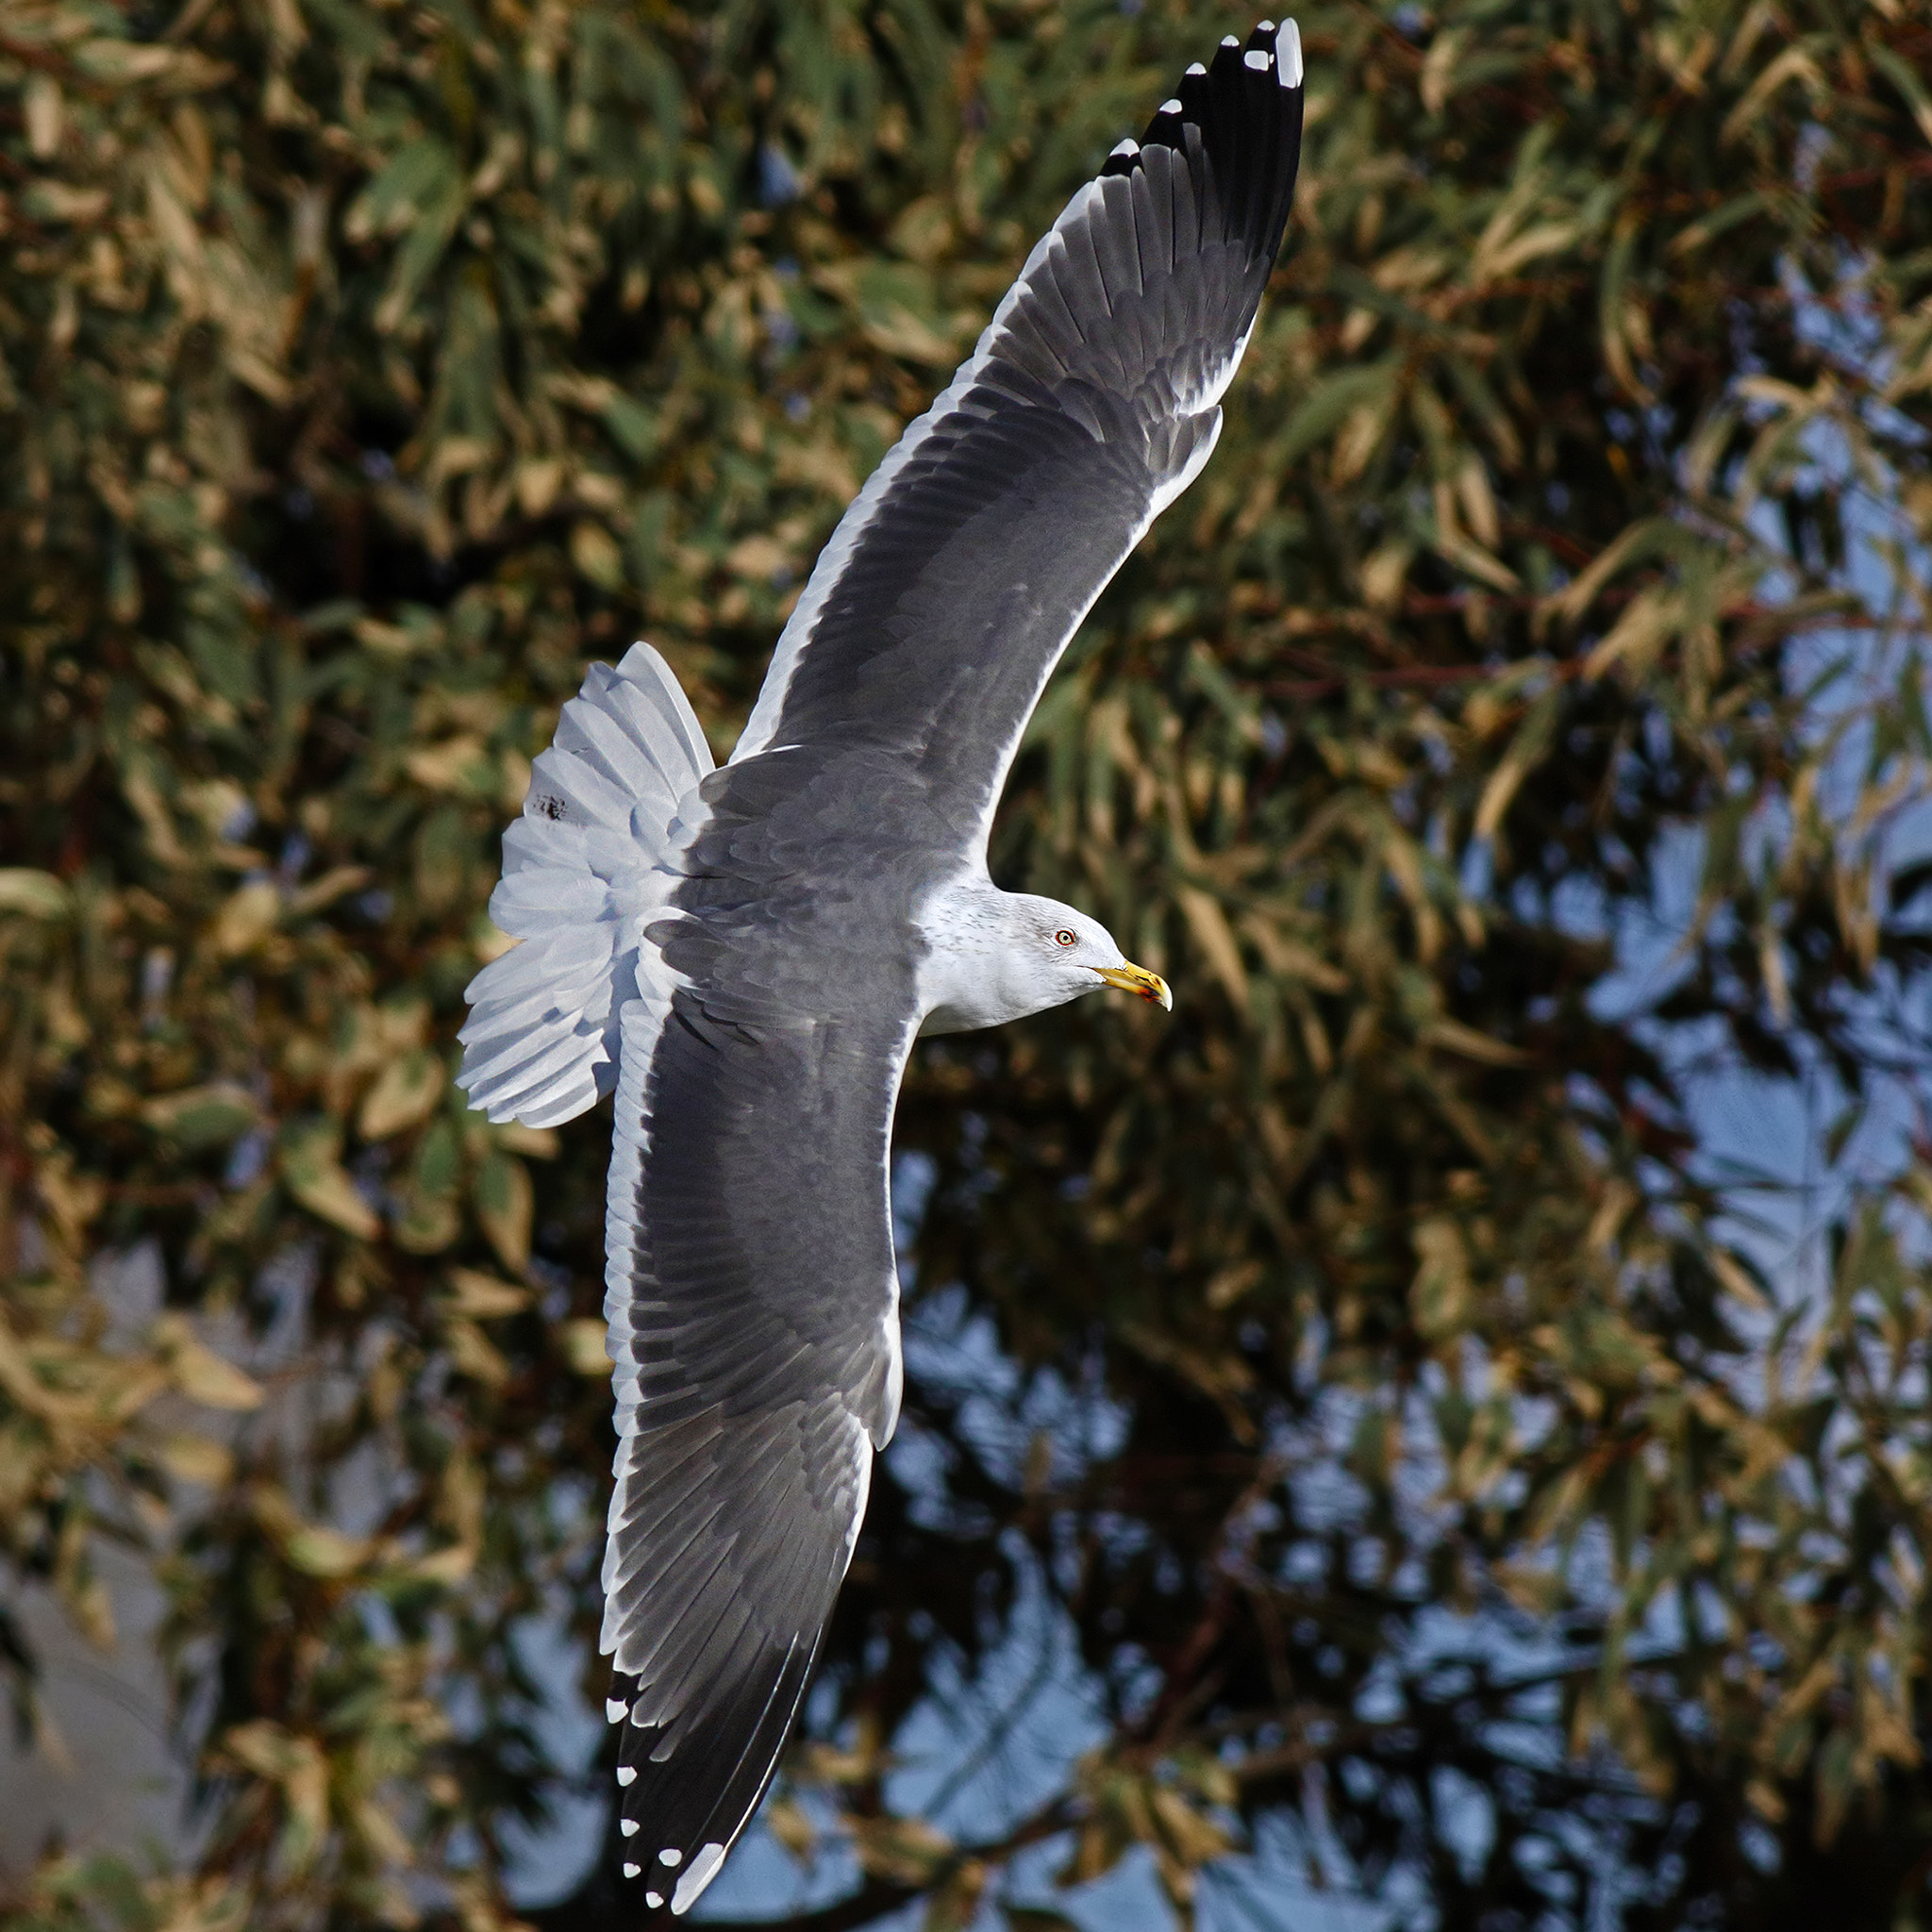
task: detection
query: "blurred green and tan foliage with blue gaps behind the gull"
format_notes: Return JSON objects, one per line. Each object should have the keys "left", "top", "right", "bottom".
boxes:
{"left": 0, "top": 0, "right": 1932, "bottom": 1932}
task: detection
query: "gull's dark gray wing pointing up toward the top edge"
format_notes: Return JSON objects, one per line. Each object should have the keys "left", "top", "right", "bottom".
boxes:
{"left": 732, "top": 22, "right": 1302, "bottom": 846}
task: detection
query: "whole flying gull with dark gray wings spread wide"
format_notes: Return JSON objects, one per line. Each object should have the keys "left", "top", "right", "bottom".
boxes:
{"left": 458, "top": 22, "right": 1302, "bottom": 1913}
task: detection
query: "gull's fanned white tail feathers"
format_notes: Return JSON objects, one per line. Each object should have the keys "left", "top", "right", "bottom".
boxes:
{"left": 456, "top": 643, "right": 713, "bottom": 1126}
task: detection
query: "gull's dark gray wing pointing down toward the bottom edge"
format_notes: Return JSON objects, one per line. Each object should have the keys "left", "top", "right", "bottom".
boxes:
{"left": 603, "top": 916, "right": 912, "bottom": 1913}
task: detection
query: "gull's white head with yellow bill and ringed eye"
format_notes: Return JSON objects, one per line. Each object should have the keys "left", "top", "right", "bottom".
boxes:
{"left": 920, "top": 885, "right": 1174, "bottom": 1034}
